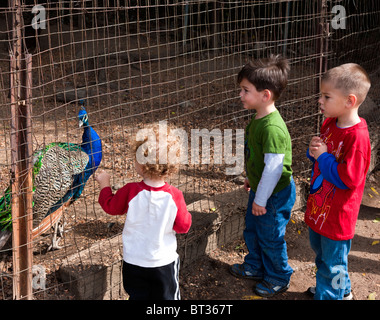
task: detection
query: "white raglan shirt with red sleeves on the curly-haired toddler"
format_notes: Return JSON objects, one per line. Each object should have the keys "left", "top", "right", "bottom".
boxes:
{"left": 99, "top": 181, "right": 191, "bottom": 268}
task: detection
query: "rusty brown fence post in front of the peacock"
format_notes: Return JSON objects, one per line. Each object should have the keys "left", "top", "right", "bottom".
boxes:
{"left": 10, "top": 0, "right": 33, "bottom": 299}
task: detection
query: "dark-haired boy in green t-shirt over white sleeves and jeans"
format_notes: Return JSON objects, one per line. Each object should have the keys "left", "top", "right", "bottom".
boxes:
{"left": 230, "top": 55, "right": 296, "bottom": 297}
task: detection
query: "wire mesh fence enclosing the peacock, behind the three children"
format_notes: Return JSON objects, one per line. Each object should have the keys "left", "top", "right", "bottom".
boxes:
{"left": 0, "top": 0, "right": 380, "bottom": 300}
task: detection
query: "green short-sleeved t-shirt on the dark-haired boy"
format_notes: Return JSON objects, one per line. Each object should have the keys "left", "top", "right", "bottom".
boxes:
{"left": 245, "top": 110, "right": 292, "bottom": 193}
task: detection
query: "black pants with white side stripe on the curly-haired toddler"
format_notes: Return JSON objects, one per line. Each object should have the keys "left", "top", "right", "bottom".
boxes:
{"left": 123, "top": 258, "right": 180, "bottom": 300}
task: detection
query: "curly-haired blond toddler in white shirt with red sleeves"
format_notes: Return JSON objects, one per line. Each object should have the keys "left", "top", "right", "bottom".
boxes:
{"left": 95, "top": 126, "right": 191, "bottom": 300}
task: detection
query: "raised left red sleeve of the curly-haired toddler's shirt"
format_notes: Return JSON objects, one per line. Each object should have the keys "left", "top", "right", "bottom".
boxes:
{"left": 98, "top": 184, "right": 134, "bottom": 215}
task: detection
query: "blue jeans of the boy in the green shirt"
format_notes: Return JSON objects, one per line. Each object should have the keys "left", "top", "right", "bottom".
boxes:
{"left": 244, "top": 178, "right": 296, "bottom": 286}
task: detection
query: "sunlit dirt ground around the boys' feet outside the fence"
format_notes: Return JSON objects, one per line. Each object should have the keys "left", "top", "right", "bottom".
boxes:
{"left": 180, "top": 171, "right": 380, "bottom": 300}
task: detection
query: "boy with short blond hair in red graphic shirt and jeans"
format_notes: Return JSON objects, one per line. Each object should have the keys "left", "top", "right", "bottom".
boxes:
{"left": 305, "top": 63, "right": 371, "bottom": 300}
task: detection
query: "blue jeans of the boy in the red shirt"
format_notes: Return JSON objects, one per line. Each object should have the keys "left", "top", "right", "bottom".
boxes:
{"left": 309, "top": 228, "right": 351, "bottom": 300}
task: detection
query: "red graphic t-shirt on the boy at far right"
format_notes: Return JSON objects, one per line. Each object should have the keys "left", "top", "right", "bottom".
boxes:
{"left": 305, "top": 118, "right": 371, "bottom": 240}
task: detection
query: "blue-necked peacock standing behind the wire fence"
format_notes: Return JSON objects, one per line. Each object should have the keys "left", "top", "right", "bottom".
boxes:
{"left": 0, "top": 104, "right": 102, "bottom": 250}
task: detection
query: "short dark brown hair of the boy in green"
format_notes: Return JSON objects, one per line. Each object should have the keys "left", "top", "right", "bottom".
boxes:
{"left": 238, "top": 55, "right": 290, "bottom": 101}
